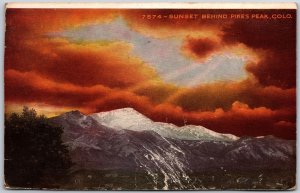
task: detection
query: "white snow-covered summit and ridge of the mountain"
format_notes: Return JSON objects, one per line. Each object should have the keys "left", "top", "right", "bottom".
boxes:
{"left": 91, "top": 108, "right": 239, "bottom": 141}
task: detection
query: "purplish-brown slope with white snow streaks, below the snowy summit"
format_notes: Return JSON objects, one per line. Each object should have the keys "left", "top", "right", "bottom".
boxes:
{"left": 51, "top": 111, "right": 193, "bottom": 189}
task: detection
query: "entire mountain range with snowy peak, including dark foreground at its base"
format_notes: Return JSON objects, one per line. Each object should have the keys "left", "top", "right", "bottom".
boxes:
{"left": 50, "top": 108, "right": 296, "bottom": 190}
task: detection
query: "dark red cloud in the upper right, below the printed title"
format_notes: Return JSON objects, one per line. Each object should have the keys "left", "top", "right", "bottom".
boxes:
{"left": 223, "top": 10, "right": 296, "bottom": 88}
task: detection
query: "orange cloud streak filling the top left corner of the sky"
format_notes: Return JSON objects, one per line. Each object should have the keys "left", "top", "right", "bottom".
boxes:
{"left": 6, "top": 9, "right": 118, "bottom": 34}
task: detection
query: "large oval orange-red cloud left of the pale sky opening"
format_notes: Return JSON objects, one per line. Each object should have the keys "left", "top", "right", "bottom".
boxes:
{"left": 5, "top": 37, "right": 158, "bottom": 87}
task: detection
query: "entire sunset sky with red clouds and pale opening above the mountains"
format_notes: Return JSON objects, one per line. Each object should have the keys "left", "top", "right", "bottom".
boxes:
{"left": 4, "top": 9, "right": 296, "bottom": 139}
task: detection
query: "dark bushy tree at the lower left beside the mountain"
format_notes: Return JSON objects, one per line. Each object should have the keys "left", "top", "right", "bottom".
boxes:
{"left": 4, "top": 107, "right": 71, "bottom": 188}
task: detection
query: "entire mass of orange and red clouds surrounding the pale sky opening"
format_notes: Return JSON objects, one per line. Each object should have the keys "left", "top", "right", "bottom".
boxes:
{"left": 5, "top": 9, "right": 296, "bottom": 139}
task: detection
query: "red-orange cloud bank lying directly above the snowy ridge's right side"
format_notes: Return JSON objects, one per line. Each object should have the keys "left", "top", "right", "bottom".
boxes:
{"left": 151, "top": 101, "right": 296, "bottom": 139}
